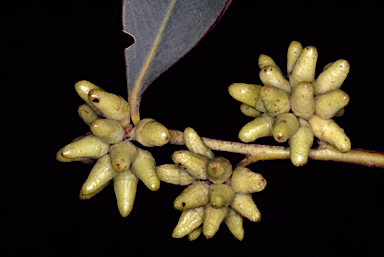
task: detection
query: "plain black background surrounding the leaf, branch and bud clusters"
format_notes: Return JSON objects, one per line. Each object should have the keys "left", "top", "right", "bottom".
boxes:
{"left": 0, "top": 0, "right": 384, "bottom": 256}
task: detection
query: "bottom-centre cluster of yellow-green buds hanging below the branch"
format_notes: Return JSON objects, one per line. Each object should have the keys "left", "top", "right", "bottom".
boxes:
{"left": 156, "top": 128, "right": 267, "bottom": 241}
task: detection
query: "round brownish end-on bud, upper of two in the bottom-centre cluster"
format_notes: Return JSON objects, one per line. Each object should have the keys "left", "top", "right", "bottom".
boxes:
{"left": 207, "top": 157, "right": 232, "bottom": 184}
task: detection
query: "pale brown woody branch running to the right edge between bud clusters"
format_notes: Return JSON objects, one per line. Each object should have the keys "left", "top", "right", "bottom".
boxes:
{"left": 169, "top": 130, "right": 384, "bottom": 168}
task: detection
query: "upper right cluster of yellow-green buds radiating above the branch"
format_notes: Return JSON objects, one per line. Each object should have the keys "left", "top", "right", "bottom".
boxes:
{"left": 228, "top": 41, "right": 351, "bottom": 166}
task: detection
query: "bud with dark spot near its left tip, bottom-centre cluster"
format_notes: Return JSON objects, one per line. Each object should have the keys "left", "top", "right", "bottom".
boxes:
{"left": 173, "top": 182, "right": 209, "bottom": 210}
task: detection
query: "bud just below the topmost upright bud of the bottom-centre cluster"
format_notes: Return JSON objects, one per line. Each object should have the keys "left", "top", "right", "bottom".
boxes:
{"left": 172, "top": 150, "right": 209, "bottom": 180}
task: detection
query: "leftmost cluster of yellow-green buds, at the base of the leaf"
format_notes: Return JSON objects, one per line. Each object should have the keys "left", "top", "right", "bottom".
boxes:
{"left": 56, "top": 80, "right": 170, "bottom": 217}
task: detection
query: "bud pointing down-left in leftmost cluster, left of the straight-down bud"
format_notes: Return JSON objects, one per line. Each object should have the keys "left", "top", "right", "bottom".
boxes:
{"left": 81, "top": 154, "right": 119, "bottom": 195}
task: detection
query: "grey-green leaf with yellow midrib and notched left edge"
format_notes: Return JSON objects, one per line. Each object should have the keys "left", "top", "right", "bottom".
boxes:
{"left": 123, "top": 0, "right": 231, "bottom": 125}
